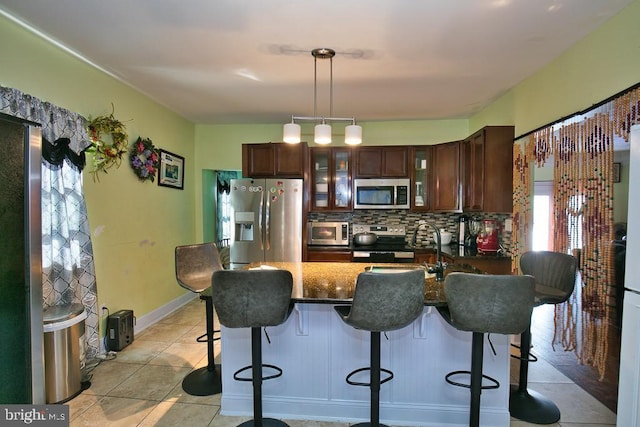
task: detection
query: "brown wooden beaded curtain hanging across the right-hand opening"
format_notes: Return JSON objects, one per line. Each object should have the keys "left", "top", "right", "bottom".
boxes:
{"left": 512, "top": 87, "right": 640, "bottom": 379}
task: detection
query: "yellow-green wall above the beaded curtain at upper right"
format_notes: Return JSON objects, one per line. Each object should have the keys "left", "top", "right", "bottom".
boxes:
{"left": 470, "top": 0, "right": 640, "bottom": 136}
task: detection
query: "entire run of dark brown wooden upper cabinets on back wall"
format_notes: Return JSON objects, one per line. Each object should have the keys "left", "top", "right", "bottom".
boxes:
{"left": 242, "top": 126, "right": 514, "bottom": 213}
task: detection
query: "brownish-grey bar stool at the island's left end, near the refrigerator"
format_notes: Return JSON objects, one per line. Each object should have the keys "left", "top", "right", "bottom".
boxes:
{"left": 175, "top": 243, "right": 222, "bottom": 396}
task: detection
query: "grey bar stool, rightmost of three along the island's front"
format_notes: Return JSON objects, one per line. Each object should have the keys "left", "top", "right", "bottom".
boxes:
{"left": 439, "top": 273, "right": 535, "bottom": 427}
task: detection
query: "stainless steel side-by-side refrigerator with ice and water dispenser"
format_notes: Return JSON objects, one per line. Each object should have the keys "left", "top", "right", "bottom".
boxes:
{"left": 230, "top": 178, "right": 303, "bottom": 269}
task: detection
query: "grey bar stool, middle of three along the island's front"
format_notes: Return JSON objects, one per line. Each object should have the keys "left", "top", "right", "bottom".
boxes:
{"left": 334, "top": 269, "right": 425, "bottom": 427}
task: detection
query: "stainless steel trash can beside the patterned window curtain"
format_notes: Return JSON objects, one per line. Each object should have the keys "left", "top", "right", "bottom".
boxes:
{"left": 43, "top": 304, "right": 87, "bottom": 403}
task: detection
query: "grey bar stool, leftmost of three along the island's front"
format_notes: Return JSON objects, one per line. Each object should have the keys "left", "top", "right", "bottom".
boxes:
{"left": 211, "top": 270, "right": 293, "bottom": 427}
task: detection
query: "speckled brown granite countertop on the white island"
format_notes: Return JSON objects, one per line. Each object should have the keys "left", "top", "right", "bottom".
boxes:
{"left": 248, "top": 262, "right": 481, "bottom": 306}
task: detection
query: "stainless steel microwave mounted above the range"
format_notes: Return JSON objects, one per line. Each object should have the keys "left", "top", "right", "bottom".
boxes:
{"left": 353, "top": 178, "right": 411, "bottom": 209}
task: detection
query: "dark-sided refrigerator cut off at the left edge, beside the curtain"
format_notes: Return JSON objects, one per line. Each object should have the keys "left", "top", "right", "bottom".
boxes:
{"left": 0, "top": 114, "right": 45, "bottom": 404}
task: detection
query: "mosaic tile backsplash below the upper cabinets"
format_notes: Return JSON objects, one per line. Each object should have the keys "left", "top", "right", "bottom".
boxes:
{"left": 308, "top": 209, "right": 512, "bottom": 254}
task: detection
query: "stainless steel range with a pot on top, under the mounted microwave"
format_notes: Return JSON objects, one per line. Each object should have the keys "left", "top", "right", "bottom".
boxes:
{"left": 353, "top": 224, "right": 415, "bottom": 263}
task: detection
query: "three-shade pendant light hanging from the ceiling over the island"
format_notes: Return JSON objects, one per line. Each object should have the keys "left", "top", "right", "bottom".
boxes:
{"left": 282, "top": 48, "right": 362, "bottom": 145}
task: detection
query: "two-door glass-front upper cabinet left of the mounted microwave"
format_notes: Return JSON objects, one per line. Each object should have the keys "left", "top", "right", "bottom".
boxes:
{"left": 309, "top": 147, "right": 352, "bottom": 211}
